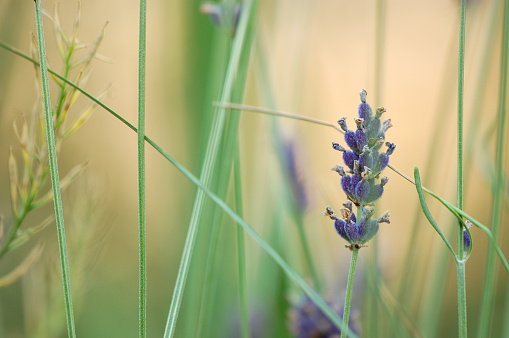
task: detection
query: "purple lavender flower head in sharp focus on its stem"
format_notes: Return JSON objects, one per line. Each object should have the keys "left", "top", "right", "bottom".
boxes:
{"left": 324, "top": 89, "right": 396, "bottom": 245}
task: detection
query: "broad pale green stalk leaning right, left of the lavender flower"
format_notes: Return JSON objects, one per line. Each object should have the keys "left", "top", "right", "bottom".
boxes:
{"left": 164, "top": 1, "right": 254, "bottom": 338}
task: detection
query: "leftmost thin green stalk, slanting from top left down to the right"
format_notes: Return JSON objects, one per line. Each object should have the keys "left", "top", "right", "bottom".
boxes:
{"left": 34, "top": 0, "right": 76, "bottom": 337}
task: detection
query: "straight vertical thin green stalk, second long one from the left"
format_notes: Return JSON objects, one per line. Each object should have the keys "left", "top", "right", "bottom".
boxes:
{"left": 138, "top": 0, "right": 147, "bottom": 338}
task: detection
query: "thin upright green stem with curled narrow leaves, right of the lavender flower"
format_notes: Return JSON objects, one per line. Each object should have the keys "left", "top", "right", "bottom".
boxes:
{"left": 456, "top": 0, "right": 467, "bottom": 338}
